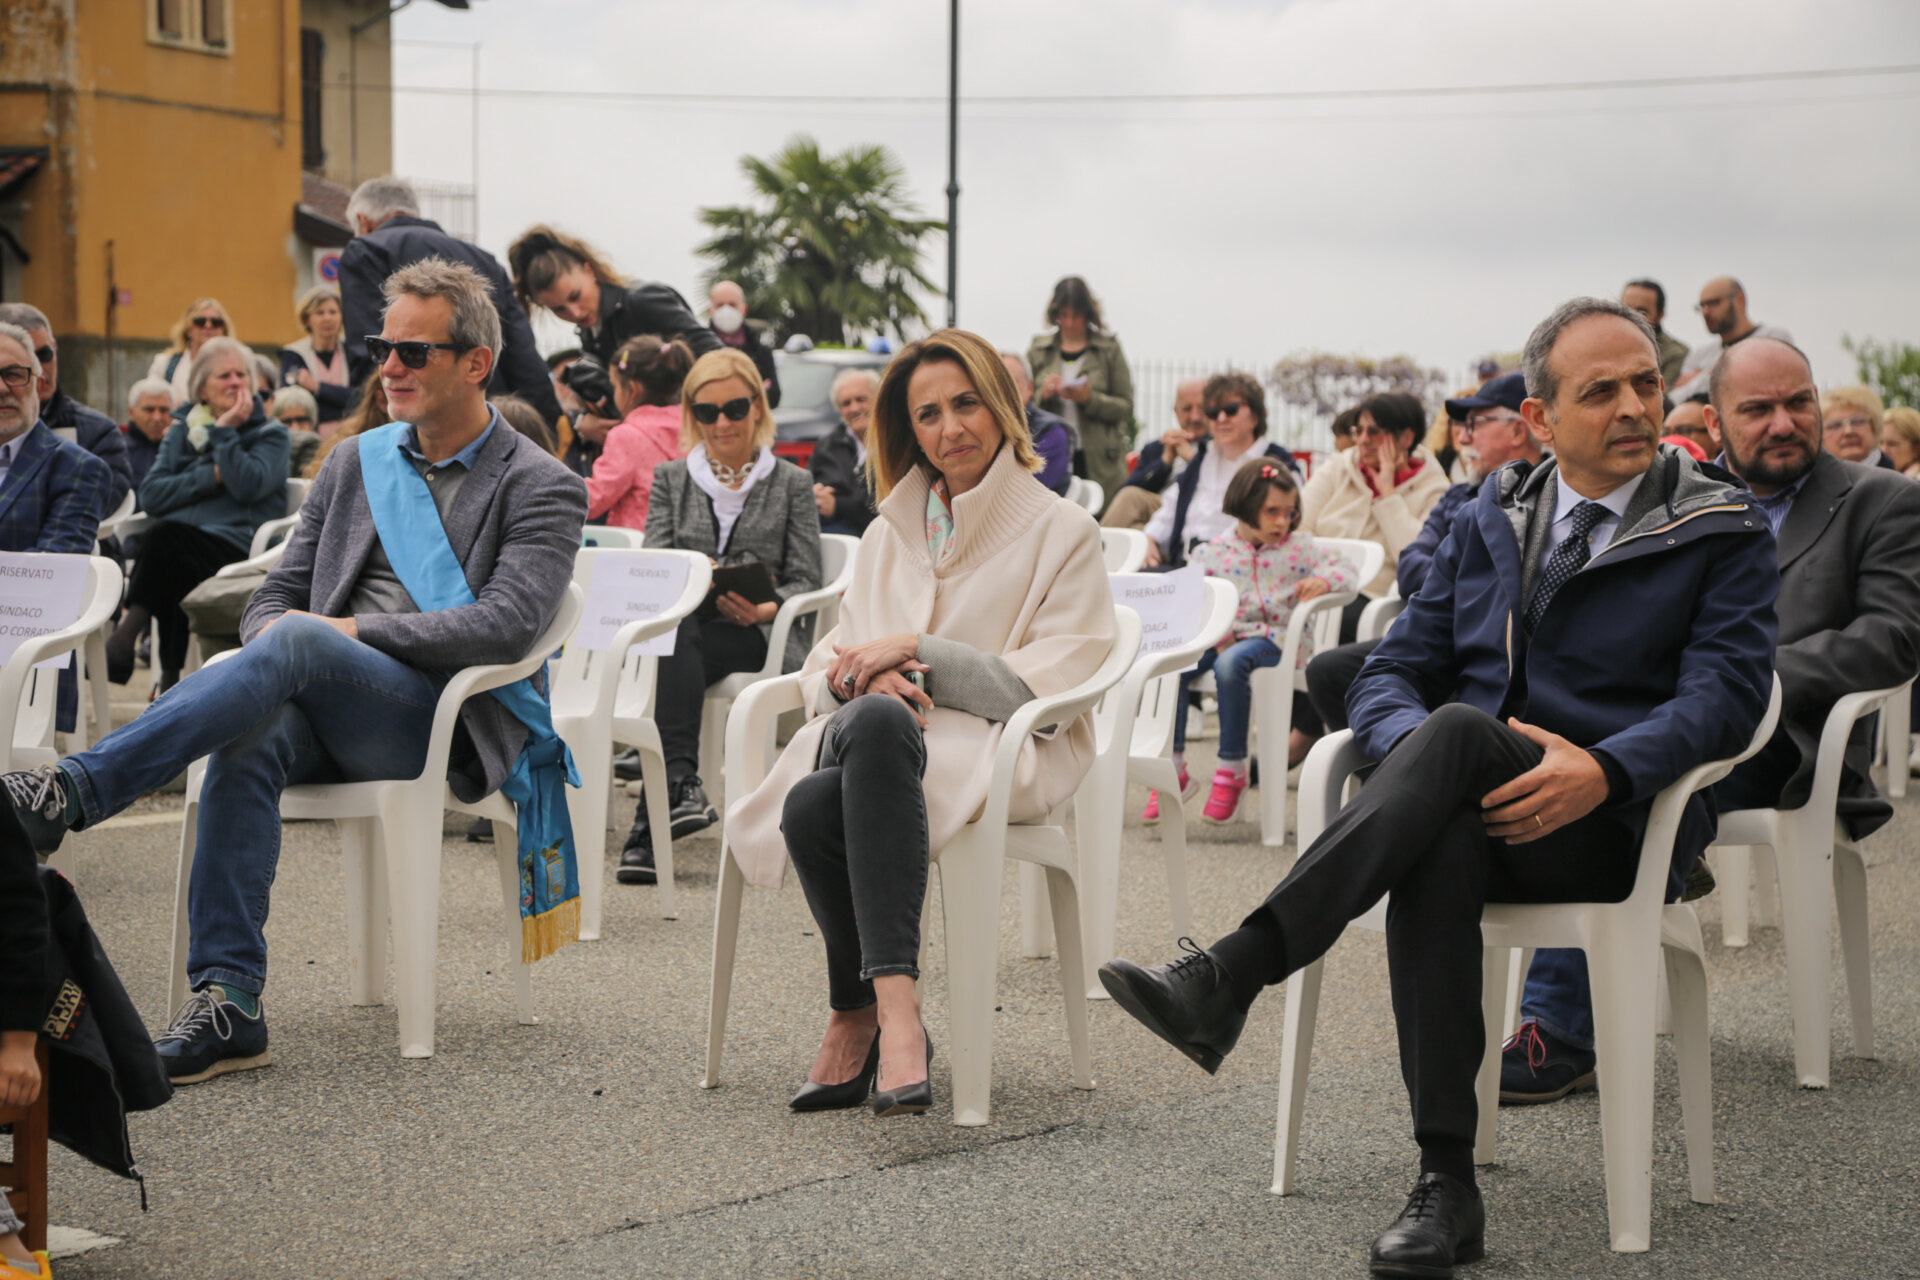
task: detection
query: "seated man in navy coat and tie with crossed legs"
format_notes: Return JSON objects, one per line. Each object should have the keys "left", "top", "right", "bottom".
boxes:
{"left": 1100, "top": 297, "right": 1780, "bottom": 1276}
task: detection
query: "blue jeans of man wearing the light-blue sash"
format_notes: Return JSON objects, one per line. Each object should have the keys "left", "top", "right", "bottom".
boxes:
{"left": 60, "top": 618, "right": 447, "bottom": 994}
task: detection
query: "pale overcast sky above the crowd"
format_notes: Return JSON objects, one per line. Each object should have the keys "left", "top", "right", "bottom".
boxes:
{"left": 394, "top": 0, "right": 1920, "bottom": 397}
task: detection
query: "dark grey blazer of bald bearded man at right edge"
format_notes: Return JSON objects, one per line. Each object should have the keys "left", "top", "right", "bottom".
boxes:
{"left": 1774, "top": 451, "right": 1920, "bottom": 837}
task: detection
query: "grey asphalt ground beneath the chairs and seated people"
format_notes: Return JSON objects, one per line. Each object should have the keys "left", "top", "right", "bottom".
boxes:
{"left": 33, "top": 721, "right": 1920, "bottom": 1280}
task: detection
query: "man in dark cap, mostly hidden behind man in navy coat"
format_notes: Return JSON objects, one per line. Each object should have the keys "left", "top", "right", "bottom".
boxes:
{"left": 1308, "top": 374, "right": 1540, "bottom": 733}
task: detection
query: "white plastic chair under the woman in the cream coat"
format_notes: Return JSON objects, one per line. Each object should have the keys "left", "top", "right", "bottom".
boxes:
{"left": 701, "top": 608, "right": 1140, "bottom": 1125}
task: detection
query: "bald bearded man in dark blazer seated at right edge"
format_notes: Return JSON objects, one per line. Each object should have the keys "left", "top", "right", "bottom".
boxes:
{"left": 1500, "top": 338, "right": 1920, "bottom": 1103}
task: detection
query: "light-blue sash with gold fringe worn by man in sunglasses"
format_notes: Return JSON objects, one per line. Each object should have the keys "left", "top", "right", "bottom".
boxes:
{"left": 359, "top": 420, "right": 580, "bottom": 963}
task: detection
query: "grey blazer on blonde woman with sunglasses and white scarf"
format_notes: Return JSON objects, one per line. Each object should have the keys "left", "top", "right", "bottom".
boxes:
{"left": 647, "top": 459, "right": 820, "bottom": 672}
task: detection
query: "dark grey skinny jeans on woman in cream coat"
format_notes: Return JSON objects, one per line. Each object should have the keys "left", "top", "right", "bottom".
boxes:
{"left": 780, "top": 693, "right": 927, "bottom": 1011}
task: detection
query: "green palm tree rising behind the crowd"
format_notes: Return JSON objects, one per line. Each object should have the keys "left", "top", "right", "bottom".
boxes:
{"left": 695, "top": 134, "right": 947, "bottom": 344}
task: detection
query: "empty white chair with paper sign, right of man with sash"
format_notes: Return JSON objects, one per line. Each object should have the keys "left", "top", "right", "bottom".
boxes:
{"left": 549, "top": 547, "right": 712, "bottom": 942}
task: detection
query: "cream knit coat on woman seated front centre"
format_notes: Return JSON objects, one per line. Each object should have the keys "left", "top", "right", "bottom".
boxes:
{"left": 726, "top": 447, "right": 1116, "bottom": 889}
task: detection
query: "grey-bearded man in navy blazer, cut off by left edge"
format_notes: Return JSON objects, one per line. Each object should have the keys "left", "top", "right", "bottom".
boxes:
{"left": 0, "top": 322, "right": 119, "bottom": 733}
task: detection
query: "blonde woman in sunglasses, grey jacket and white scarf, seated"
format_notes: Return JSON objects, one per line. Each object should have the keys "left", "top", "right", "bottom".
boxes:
{"left": 618, "top": 347, "right": 820, "bottom": 885}
